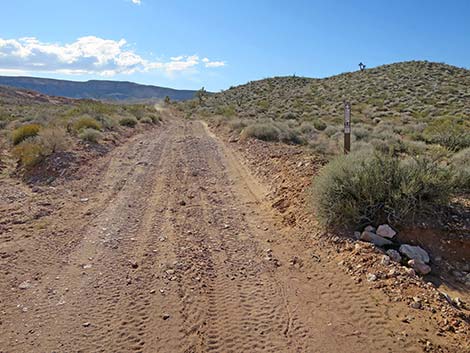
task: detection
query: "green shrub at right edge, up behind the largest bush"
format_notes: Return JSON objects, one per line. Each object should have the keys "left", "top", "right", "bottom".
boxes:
{"left": 423, "top": 117, "right": 470, "bottom": 151}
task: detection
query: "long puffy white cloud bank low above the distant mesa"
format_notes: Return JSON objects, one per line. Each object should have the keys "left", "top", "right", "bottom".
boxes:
{"left": 0, "top": 36, "right": 225, "bottom": 76}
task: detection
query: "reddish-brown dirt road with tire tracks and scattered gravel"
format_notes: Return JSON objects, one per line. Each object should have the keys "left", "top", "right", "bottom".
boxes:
{"left": 0, "top": 120, "right": 462, "bottom": 353}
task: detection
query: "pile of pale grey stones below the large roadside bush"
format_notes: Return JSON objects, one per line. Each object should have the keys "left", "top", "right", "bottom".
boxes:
{"left": 355, "top": 224, "right": 431, "bottom": 275}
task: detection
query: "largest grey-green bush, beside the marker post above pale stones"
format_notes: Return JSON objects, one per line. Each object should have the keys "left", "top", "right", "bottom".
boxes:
{"left": 312, "top": 152, "right": 453, "bottom": 225}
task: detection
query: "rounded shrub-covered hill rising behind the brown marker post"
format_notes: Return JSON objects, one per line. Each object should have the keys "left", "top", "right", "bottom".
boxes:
{"left": 187, "top": 61, "right": 470, "bottom": 154}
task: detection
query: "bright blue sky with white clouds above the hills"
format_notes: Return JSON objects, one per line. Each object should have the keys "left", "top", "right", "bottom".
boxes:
{"left": 0, "top": 0, "right": 470, "bottom": 91}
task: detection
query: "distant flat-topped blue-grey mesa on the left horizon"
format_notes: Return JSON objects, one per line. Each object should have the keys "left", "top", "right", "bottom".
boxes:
{"left": 0, "top": 76, "right": 195, "bottom": 101}
